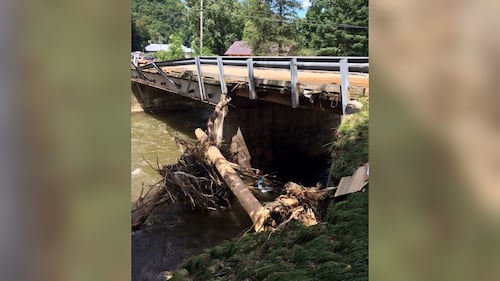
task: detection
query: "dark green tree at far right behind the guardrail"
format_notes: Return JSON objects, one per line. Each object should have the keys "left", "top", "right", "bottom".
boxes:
{"left": 303, "top": 0, "right": 368, "bottom": 56}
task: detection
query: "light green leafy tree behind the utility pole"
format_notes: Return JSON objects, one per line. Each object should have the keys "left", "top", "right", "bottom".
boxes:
{"left": 186, "top": 0, "right": 245, "bottom": 55}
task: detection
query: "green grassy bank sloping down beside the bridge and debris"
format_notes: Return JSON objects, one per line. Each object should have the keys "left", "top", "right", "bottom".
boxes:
{"left": 172, "top": 97, "right": 368, "bottom": 281}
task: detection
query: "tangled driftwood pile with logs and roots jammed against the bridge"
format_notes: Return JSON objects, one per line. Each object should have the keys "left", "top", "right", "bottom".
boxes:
{"left": 132, "top": 96, "right": 338, "bottom": 232}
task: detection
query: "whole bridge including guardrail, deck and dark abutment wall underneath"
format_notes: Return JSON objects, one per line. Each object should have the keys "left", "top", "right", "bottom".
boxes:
{"left": 131, "top": 57, "right": 369, "bottom": 184}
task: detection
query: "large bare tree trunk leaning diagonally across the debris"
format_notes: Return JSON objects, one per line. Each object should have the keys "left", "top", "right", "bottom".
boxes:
{"left": 195, "top": 128, "right": 269, "bottom": 232}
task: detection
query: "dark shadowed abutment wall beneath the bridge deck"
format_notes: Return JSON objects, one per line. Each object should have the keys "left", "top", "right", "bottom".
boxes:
{"left": 224, "top": 100, "right": 341, "bottom": 185}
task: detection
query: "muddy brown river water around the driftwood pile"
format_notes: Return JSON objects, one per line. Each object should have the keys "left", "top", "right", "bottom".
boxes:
{"left": 131, "top": 108, "right": 252, "bottom": 281}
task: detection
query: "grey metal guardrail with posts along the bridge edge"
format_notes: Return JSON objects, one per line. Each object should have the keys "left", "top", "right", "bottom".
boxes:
{"left": 134, "top": 56, "right": 369, "bottom": 113}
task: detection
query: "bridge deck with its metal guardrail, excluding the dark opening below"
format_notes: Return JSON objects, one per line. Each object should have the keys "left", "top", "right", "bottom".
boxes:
{"left": 131, "top": 57, "right": 369, "bottom": 114}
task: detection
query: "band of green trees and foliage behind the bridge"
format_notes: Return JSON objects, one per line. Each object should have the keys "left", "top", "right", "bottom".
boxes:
{"left": 132, "top": 0, "right": 368, "bottom": 56}
